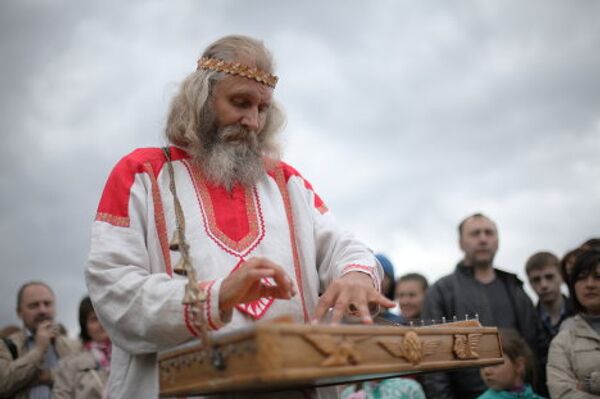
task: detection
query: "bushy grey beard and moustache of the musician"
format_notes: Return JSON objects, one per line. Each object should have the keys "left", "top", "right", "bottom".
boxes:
{"left": 195, "top": 125, "right": 265, "bottom": 191}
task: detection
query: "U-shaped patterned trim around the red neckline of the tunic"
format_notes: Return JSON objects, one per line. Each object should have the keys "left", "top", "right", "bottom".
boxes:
{"left": 184, "top": 161, "right": 265, "bottom": 257}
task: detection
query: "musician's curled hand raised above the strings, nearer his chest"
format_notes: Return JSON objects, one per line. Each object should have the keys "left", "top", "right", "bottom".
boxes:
{"left": 219, "top": 258, "right": 296, "bottom": 312}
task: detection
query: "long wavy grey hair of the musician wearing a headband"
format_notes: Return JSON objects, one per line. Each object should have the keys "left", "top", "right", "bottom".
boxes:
{"left": 165, "top": 36, "right": 285, "bottom": 170}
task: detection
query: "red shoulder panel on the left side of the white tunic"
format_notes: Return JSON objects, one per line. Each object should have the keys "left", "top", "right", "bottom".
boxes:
{"left": 96, "top": 147, "right": 188, "bottom": 227}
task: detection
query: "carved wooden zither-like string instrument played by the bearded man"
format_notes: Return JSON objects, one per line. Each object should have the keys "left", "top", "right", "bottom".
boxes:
{"left": 158, "top": 322, "right": 503, "bottom": 396}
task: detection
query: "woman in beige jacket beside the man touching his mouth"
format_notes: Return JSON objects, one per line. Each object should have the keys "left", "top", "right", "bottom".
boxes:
{"left": 52, "top": 297, "right": 111, "bottom": 399}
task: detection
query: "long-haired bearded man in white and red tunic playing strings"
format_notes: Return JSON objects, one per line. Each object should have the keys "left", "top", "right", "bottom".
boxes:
{"left": 86, "top": 36, "right": 393, "bottom": 398}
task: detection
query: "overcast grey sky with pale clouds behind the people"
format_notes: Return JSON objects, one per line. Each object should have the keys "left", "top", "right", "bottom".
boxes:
{"left": 0, "top": 0, "right": 600, "bottom": 335}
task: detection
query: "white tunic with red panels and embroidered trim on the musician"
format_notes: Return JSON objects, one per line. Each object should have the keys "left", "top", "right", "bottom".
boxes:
{"left": 86, "top": 147, "right": 382, "bottom": 398}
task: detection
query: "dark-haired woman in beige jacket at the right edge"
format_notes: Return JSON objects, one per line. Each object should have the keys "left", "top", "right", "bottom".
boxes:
{"left": 547, "top": 248, "right": 600, "bottom": 398}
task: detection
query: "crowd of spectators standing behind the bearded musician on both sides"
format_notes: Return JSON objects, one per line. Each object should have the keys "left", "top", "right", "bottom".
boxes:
{"left": 0, "top": 213, "right": 600, "bottom": 399}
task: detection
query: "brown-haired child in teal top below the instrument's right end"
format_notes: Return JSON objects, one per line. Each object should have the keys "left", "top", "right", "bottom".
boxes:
{"left": 479, "top": 330, "right": 543, "bottom": 399}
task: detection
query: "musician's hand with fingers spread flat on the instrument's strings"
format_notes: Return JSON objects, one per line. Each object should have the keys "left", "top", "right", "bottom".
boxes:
{"left": 312, "top": 272, "right": 395, "bottom": 324}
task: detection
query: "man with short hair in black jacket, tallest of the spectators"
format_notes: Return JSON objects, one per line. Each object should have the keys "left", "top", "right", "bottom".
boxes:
{"left": 423, "top": 213, "right": 547, "bottom": 399}
